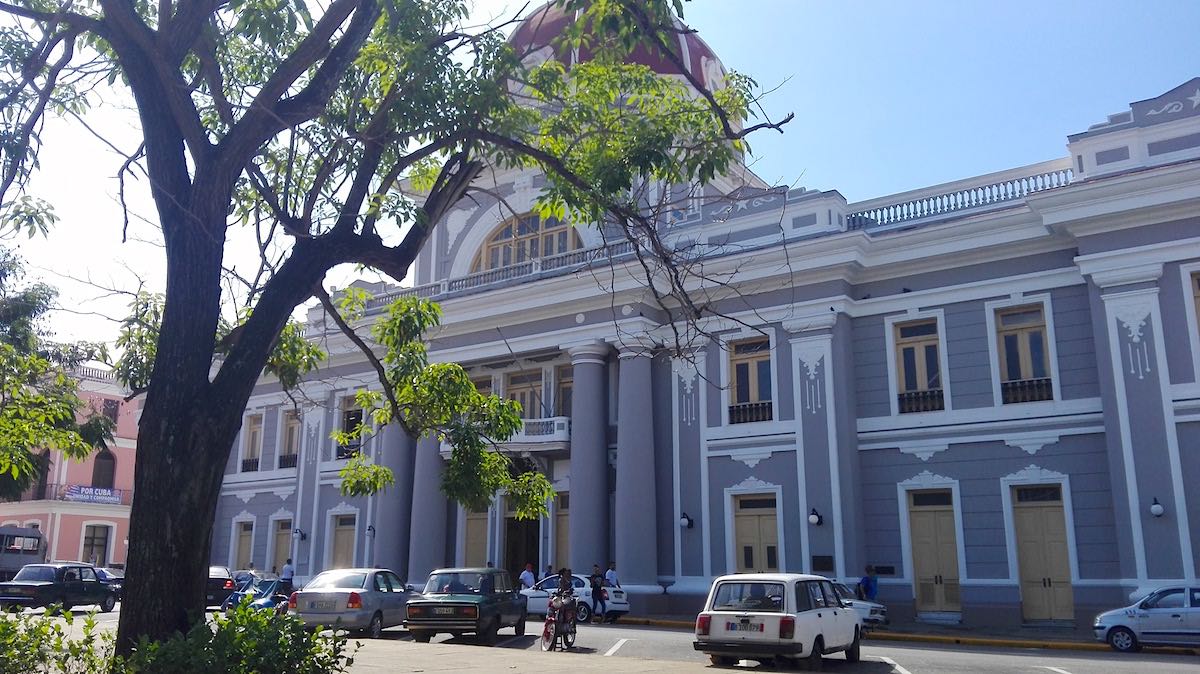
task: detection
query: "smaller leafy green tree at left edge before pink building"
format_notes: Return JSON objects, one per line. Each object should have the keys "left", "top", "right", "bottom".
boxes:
{"left": 0, "top": 248, "right": 112, "bottom": 499}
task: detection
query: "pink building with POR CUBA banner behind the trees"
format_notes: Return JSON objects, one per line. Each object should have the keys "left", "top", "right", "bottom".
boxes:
{"left": 0, "top": 367, "right": 140, "bottom": 567}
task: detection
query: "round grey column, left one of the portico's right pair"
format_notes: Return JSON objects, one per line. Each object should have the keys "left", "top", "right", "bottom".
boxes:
{"left": 559, "top": 342, "right": 611, "bottom": 573}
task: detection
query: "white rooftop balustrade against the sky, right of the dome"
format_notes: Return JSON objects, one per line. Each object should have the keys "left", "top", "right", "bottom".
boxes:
{"left": 847, "top": 158, "right": 1073, "bottom": 229}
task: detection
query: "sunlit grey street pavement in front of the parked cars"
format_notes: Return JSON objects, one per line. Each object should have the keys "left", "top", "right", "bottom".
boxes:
{"left": 11, "top": 607, "right": 1200, "bottom": 674}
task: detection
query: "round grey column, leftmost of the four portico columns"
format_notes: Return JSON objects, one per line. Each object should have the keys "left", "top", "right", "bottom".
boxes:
{"left": 368, "top": 423, "right": 415, "bottom": 578}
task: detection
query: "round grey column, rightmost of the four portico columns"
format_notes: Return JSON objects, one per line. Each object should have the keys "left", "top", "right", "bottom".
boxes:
{"left": 614, "top": 345, "right": 662, "bottom": 592}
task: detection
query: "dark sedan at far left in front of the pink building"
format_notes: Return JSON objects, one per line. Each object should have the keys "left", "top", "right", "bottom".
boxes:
{"left": 0, "top": 561, "right": 116, "bottom": 613}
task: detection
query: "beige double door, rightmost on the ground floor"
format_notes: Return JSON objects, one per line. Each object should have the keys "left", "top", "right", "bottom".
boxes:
{"left": 1013, "top": 485, "right": 1075, "bottom": 620}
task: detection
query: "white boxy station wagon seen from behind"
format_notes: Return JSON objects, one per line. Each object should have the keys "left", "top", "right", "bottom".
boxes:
{"left": 692, "top": 573, "right": 863, "bottom": 669}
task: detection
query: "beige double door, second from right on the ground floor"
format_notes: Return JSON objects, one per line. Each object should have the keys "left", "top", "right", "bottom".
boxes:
{"left": 908, "top": 489, "right": 962, "bottom": 612}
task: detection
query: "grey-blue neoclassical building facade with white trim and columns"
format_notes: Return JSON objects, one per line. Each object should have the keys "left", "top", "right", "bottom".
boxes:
{"left": 211, "top": 9, "right": 1200, "bottom": 624}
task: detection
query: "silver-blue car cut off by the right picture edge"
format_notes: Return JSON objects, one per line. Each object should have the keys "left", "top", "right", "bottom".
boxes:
{"left": 1092, "top": 586, "right": 1200, "bottom": 652}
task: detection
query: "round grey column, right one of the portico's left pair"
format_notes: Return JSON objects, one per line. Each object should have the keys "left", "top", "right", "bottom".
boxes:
{"left": 408, "top": 435, "right": 448, "bottom": 588}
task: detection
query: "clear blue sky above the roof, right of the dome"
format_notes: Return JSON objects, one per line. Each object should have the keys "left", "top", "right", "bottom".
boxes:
{"left": 684, "top": 0, "right": 1200, "bottom": 201}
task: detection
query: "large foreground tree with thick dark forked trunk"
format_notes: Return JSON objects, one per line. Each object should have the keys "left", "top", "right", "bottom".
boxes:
{"left": 0, "top": 0, "right": 786, "bottom": 652}
